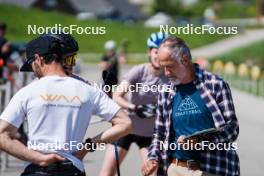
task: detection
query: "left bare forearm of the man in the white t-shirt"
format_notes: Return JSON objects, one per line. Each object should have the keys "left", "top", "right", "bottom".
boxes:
{"left": 0, "top": 133, "right": 42, "bottom": 164}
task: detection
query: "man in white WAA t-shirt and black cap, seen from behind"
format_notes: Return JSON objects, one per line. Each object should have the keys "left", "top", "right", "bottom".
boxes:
{"left": 0, "top": 36, "right": 131, "bottom": 176}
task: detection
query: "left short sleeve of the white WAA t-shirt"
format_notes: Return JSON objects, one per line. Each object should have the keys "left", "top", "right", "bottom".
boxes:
{"left": 0, "top": 92, "right": 26, "bottom": 128}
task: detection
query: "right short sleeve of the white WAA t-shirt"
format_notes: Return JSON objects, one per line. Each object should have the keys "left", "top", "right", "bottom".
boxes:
{"left": 92, "top": 89, "right": 121, "bottom": 121}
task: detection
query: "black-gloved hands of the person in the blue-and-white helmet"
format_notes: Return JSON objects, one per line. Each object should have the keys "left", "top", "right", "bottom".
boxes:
{"left": 128, "top": 104, "right": 157, "bottom": 119}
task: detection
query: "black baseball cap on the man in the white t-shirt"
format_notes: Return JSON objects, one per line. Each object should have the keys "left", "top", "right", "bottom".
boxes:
{"left": 20, "top": 36, "right": 62, "bottom": 72}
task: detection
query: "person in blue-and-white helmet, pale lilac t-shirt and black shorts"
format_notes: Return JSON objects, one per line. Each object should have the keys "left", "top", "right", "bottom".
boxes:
{"left": 100, "top": 32, "right": 169, "bottom": 176}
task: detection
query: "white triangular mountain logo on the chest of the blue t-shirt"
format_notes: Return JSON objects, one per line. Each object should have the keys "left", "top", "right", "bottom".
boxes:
{"left": 175, "top": 96, "right": 202, "bottom": 116}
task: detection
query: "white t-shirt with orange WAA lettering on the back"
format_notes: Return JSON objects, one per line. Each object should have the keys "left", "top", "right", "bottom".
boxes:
{"left": 0, "top": 76, "right": 120, "bottom": 171}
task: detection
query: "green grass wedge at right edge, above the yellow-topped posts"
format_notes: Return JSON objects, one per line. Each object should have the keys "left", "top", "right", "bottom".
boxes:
{"left": 210, "top": 41, "right": 264, "bottom": 69}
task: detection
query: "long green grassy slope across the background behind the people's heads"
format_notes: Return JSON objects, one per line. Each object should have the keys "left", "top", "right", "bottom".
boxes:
{"left": 0, "top": 4, "right": 228, "bottom": 53}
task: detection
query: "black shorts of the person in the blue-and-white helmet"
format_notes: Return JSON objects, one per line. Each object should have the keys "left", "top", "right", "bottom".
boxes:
{"left": 117, "top": 134, "right": 151, "bottom": 150}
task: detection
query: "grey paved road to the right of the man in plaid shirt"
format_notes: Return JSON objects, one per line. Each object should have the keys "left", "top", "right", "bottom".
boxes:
{"left": 233, "top": 90, "right": 264, "bottom": 176}
